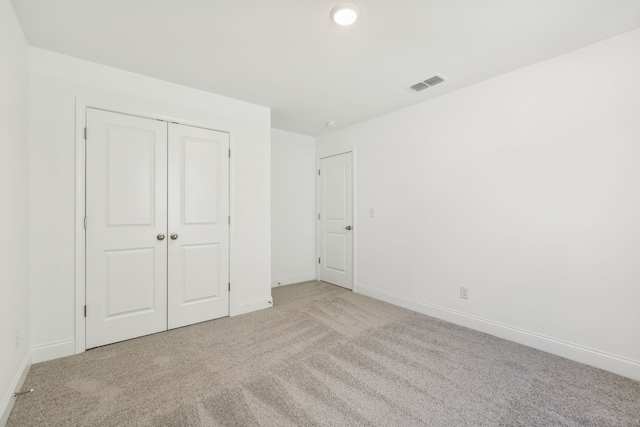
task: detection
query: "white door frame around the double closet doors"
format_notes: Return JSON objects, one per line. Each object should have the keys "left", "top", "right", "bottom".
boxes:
{"left": 73, "top": 97, "right": 234, "bottom": 354}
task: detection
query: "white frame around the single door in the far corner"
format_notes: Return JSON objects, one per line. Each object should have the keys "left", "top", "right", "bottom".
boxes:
{"left": 314, "top": 147, "right": 358, "bottom": 292}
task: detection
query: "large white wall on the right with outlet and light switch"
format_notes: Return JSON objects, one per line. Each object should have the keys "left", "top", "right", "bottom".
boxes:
{"left": 317, "top": 30, "right": 640, "bottom": 379}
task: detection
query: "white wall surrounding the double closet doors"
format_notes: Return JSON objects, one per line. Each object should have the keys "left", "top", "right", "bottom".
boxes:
{"left": 29, "top": 48, "right": 271, "bottom": 361}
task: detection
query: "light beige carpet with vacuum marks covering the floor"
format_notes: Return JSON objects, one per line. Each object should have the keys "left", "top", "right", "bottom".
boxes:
{"left": 8, "top": 282, "right": 640, "bottom": 427}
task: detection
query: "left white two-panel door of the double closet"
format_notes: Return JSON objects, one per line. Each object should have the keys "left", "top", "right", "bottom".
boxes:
{"left": 86, "top": 109, "right": 167, "bottom": 348}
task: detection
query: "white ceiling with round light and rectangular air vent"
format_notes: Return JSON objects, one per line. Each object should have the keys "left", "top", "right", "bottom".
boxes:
{"left": 13, "top": 0, "right": 640, "bottom": 136}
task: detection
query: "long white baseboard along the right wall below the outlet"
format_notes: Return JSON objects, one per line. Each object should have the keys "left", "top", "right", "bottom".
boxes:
{"left": 353, "top": 284, "right": 640, "bottom": 381}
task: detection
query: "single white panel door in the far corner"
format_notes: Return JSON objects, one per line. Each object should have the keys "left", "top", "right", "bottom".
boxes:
{"left": 318, "top": 153, "right": 353, "bottom": 289}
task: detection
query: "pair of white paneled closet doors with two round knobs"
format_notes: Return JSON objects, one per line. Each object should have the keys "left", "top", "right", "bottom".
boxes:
{"left": 85, "top": 109, "right": 229, "bottom": 348}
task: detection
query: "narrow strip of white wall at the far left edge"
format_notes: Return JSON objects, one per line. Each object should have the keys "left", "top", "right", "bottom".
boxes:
{"left": 0, "top": 0, "right": 31, "bottom": 425}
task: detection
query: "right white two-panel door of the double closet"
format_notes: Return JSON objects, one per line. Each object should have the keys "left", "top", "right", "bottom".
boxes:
{"left": 168, "top": 124, "right": 229, "bottom": 329}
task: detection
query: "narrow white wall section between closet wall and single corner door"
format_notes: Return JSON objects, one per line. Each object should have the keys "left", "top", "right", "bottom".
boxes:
{"left": 271, "top": 129, "right": 316, "bottom": 286}
